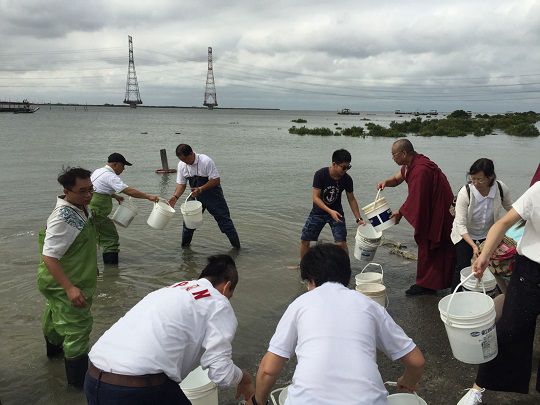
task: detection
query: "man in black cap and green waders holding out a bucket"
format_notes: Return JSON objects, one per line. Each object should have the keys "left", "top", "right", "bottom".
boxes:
{"left": 90, "top": 153, "right": 159, "bottom": 264}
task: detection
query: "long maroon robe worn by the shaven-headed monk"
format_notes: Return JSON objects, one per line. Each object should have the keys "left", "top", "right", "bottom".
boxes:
{"left": 399, "top": 154, "right": 455, "bottom": 290}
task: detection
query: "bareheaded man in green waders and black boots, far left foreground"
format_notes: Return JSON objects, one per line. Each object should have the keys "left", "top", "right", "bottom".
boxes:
{"left": 37, "top": 167, "right": 97, "bottom": 387}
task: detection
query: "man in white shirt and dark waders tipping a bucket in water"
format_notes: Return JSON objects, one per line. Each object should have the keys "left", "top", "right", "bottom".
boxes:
{"left": 169, "top": 143, "right": 240, "bottom": 249}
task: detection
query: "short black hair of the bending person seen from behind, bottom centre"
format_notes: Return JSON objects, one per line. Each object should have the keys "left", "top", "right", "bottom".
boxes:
{"left": 300, "top": 243, "right": 351, "bottom": 287}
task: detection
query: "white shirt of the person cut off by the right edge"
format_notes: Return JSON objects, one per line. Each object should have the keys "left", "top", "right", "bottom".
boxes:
{"left": 512, "top": 181, "right": 540, "bottom": 263}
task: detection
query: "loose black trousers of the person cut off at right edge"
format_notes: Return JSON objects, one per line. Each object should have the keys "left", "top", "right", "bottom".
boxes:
{"left": 476, "top": 255, "right": 540, "bottom": 394}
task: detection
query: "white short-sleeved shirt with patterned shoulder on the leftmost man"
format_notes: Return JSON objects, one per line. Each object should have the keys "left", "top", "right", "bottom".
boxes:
{"left": 42, "top": 196, "right": 88, "bottom": 260}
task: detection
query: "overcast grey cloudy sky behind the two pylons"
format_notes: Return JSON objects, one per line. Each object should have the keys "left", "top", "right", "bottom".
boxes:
{"left": 0, "top": 0, "right": 540, "bottom": 112}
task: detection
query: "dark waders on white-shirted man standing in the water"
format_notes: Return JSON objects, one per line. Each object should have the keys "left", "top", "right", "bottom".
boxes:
{"left": 182, "top": 187, "right": 240, "bottom": 247}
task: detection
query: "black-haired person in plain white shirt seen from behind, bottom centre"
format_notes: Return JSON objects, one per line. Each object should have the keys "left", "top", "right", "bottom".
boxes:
{"left": 248, "top": 244, "right": 424, "bottom": 405}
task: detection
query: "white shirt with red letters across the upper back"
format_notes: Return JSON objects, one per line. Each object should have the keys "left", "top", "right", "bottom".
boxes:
{"left": 88, "top": 278, "right": 242, "bottom": 386}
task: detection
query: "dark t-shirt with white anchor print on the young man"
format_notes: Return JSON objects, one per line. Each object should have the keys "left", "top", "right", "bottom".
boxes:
{"left": 311, "top": 167, "right": 353, "bottom": 215}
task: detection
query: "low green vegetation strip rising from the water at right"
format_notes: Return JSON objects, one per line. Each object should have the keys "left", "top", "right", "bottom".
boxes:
{"left": 289, "top": 110, "right": 540, "bottom": 138}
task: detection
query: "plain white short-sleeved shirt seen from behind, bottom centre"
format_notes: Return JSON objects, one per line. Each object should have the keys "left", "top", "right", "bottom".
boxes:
{"left": 268, "top": 282, "right": 415, "bottom": 405}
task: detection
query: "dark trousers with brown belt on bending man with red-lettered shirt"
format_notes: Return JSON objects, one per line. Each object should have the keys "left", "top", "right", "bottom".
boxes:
{"left": 84, "top": 373, "right": 191, "bottom": 405}
